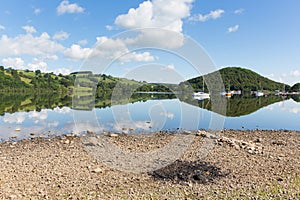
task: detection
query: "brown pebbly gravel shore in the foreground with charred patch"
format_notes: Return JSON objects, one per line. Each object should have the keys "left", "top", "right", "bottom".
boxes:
{"left": 0, "top": 130, "right": 300, "bottom": 199}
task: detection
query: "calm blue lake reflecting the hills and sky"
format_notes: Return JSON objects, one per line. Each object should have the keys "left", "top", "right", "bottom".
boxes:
{"left": 0, "top": 94, "right": 300, "bottom": 141}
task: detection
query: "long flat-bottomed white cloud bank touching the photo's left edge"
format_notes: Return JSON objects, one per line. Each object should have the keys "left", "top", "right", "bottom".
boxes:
{"left": 0, "top": 32, "right": 64, "bottom": 56}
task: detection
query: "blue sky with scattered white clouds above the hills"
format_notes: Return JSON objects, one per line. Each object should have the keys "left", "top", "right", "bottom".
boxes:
{"left": 0, "top": 0, "right": 300, "bottom": 85}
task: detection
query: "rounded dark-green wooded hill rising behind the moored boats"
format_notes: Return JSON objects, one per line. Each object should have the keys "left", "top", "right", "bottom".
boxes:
{"left": 181, "top": 67, "right": 291, "bottom": 92}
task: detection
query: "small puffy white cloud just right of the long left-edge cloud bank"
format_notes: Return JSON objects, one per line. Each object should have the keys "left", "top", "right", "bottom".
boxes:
{"left": 64, "top": 44, "right": 92, "bottom": 60}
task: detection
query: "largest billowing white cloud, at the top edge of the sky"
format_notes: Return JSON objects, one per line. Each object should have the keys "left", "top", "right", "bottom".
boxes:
{"left": 115, "top": 0, "right": 193, "bottom": 32}
